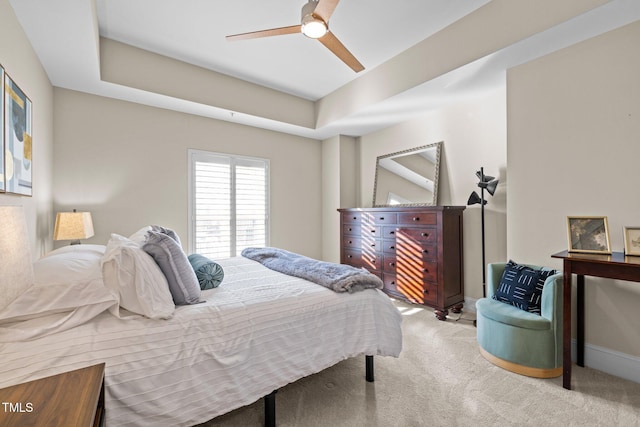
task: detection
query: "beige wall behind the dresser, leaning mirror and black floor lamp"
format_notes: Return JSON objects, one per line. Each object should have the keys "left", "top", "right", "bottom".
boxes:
{"left": 359, "top": 89, "right": 507, "bottom": 300}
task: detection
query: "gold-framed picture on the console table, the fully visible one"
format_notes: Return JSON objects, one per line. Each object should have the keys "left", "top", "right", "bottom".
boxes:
{"left": 567, "top": 216, "right": 612, "bottom": 254}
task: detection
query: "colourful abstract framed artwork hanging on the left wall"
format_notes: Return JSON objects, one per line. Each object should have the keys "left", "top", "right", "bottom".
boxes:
{"left": 2, "top": 72, "right": 33, "bottom": 196}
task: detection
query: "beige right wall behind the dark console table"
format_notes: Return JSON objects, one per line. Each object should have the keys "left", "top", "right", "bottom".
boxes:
{"left": 507, "top": 22, "right": 640, "bottom": 365}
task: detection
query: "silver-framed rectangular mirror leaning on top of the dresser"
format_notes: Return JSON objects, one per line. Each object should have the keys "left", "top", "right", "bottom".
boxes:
{"left": 373, "top": 142, "right": 442, "bottom": 207}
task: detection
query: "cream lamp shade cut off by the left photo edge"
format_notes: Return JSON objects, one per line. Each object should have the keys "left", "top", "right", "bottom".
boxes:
{"left": 0, "top": 206, "right": 33, "bottom": 310}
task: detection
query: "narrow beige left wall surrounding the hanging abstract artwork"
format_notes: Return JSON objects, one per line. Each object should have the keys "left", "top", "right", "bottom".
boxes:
{"left": 0, "top": 0, "right": 54, "bottom": 258}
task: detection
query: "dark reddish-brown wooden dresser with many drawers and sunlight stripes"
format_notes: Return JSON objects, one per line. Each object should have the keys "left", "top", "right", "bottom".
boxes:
{"left": 338, "top": 206, "right": 465, "bottom": 320}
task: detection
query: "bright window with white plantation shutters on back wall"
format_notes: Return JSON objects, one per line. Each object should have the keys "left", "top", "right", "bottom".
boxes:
{"left": 189, "top": 150, "right": 269, "bottom": 259}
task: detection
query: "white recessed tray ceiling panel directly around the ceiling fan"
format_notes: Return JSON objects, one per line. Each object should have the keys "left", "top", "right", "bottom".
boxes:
{"left": 97, "top": 0, "right": 489, "bottom": 100}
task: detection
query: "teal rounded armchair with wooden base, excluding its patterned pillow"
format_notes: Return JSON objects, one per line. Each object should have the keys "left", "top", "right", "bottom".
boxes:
{"left": 476, "top": 263, "right": 563, "bottom": 378}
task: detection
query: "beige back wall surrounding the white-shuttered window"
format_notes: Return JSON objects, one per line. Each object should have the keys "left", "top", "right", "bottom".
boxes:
{"left": 54, "top": 88, "right": 322, "bottom": 257}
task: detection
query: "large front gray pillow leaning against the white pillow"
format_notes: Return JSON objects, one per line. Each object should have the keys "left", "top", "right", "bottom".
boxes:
{"left": 142, "top": 231, "right": 200, "bottom": 305}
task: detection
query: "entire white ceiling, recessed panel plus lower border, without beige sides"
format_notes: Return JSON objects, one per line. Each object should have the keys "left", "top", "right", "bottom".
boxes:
{"left": 9, "top": 0, "right": 640, "bottom": 139}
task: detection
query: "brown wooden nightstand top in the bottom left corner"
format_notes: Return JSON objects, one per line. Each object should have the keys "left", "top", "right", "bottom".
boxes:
{"left": 0, "top": 363, "right": 104, "bottom": 427}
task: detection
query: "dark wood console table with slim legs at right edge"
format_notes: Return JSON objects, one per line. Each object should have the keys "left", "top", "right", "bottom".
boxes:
{"left": 551, "top": 251, "right": 640, "bottom": 390}
